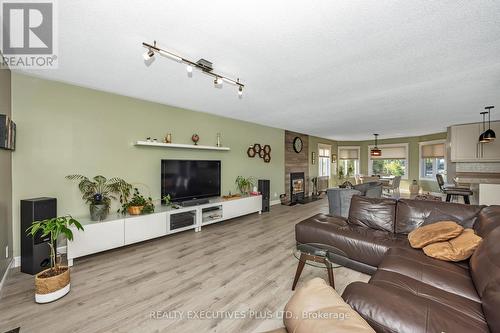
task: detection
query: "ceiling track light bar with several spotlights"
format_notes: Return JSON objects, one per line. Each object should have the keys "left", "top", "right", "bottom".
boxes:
{"left": 142, "top": 41, "right": 245, "bottom": 98}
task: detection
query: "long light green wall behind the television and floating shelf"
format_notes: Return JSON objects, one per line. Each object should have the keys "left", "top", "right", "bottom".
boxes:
{"left": 12, "top": 74, "right": 285, "bottom": 256}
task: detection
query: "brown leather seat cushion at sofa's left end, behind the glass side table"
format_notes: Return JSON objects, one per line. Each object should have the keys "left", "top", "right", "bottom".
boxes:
{"left": 295, "top": 214, "right": 410, "bottom": 267}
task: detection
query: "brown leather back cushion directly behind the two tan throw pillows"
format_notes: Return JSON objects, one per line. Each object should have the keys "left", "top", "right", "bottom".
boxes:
{"left": 395, "top": 199, "right": 484, "bottom": 234}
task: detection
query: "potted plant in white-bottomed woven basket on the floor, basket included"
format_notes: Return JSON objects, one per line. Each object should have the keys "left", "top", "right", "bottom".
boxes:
{"left": 26, "top": 215, "right": 83, "bottom": 303}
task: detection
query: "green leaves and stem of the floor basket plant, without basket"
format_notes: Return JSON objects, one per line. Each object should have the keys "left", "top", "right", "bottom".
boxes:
{"left": 26, "top": 215, "right": 83, "bottom": 276}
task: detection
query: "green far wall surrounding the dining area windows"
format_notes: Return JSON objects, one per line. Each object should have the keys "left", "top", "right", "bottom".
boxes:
{"left": 337, "top": 132, "right": 447, "bottom": 192}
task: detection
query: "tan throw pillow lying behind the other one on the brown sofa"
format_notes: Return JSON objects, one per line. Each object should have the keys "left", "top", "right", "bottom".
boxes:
{"left": 408, "top": 221, "right": 464, "bottom": 249}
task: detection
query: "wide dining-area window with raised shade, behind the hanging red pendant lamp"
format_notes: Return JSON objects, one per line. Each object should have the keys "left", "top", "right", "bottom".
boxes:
{"left": 368, "top": 143, "right": 408, "bottom": 179}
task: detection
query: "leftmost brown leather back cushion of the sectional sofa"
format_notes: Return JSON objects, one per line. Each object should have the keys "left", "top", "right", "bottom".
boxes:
{"left": 348, "top": 196, "right": 396, "bottom": 232}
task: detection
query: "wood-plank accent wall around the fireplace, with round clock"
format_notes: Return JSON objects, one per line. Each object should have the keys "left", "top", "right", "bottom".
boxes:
{"left": 285, "top": 131, "right": 310, "bottom": 200}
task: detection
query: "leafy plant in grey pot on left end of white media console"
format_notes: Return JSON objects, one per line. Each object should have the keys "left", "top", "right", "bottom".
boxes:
{"left": 66, "top": 175, "right": 132, "bottom": 221}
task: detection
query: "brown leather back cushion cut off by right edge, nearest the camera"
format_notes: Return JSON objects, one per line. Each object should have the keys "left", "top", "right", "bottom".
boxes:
{"left": 470, "top": 227, "right": 500, "bottom": 297}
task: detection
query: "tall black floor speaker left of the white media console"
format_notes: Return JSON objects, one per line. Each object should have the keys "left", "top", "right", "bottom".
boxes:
{"left": 21, "top": 198, "right": 57, "bottom": 275}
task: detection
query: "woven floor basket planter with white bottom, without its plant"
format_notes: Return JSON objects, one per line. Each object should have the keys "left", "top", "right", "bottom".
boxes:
{"left": 35, "top": 266, "right": 71, "bottom": 303}
